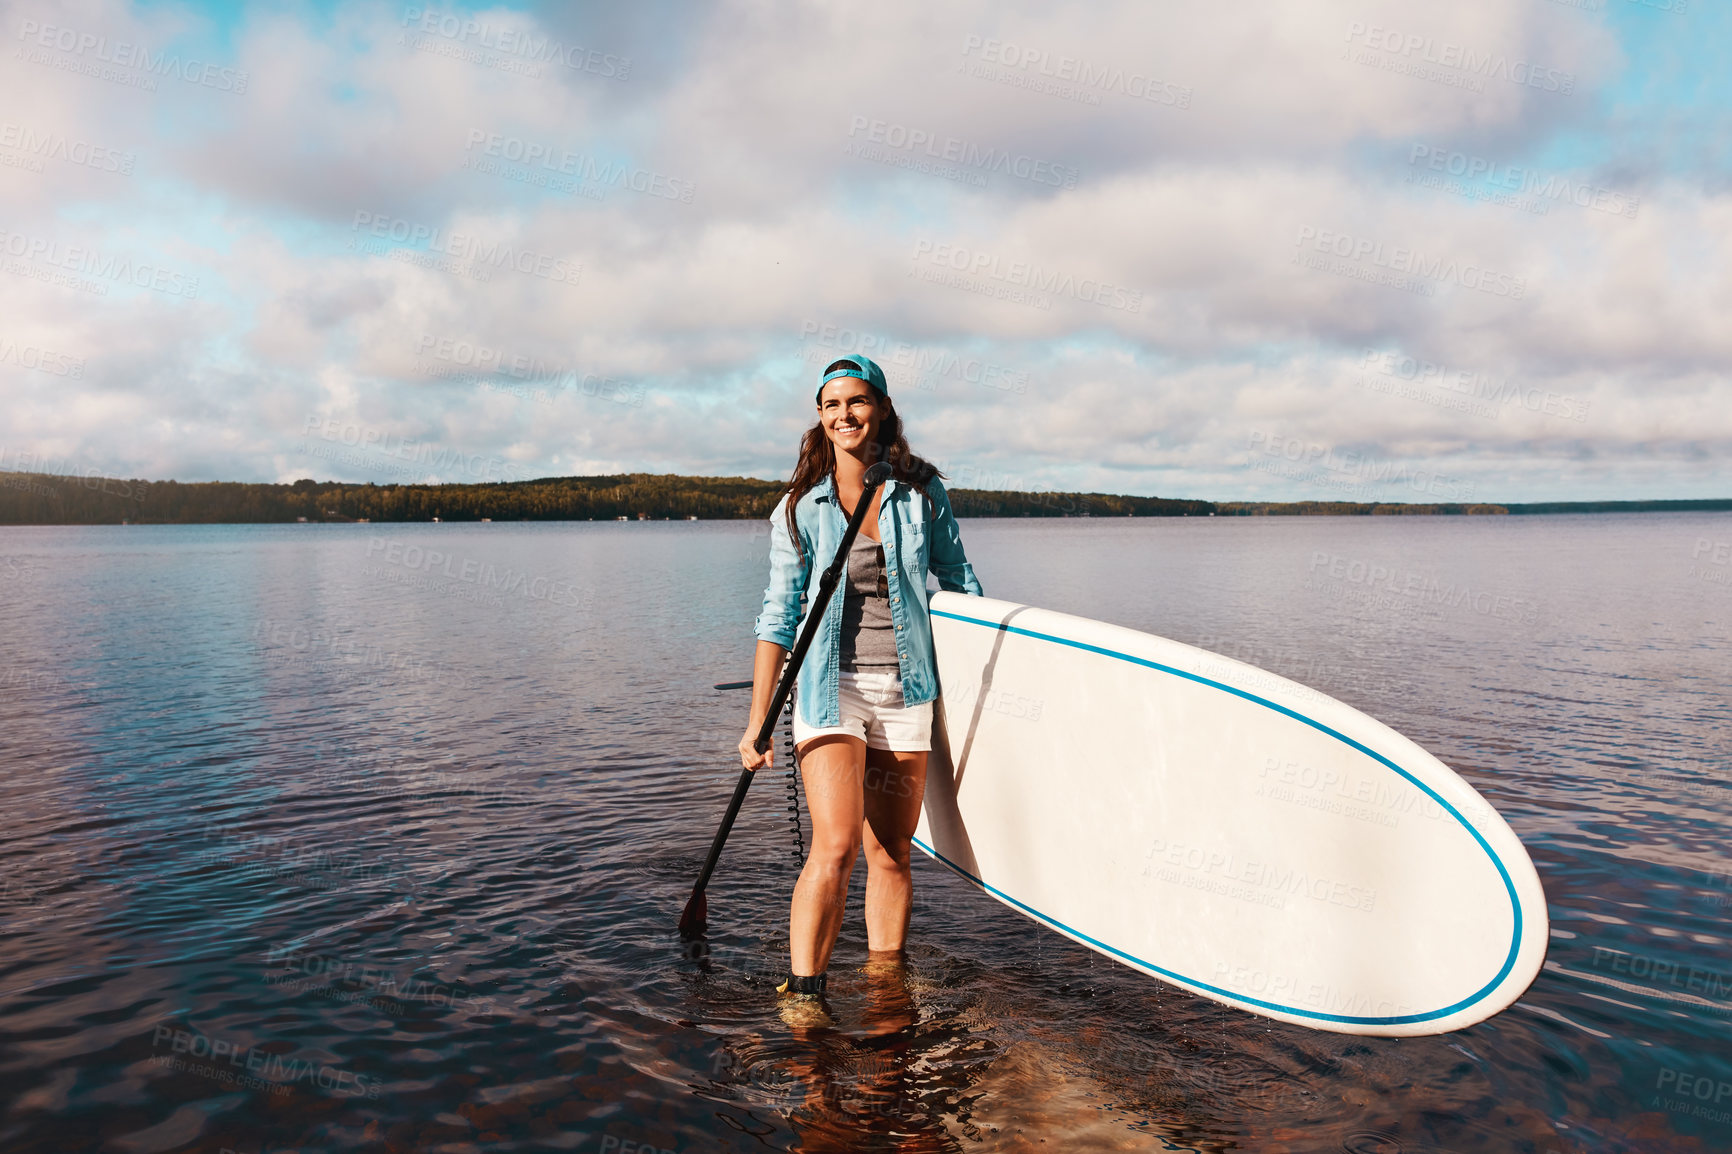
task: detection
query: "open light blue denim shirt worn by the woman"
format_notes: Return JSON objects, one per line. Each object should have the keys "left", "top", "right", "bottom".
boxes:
{"left": 753, "top": 477, "right": 982, "bottom": 728}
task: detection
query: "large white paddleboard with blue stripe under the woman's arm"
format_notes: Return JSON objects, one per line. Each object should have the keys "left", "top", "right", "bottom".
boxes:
{"left": 914, "top": 593, "right": 1548, "bottom": 1034}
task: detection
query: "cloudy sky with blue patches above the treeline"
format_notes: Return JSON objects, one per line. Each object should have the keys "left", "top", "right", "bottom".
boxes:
{"left": 0, "top": 0, "right": 1732, "bottom": 501}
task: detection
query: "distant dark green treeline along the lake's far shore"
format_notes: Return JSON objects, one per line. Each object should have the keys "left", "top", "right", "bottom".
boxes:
{"left": 0, "top": 473, "right": 1732, "bottom": 525}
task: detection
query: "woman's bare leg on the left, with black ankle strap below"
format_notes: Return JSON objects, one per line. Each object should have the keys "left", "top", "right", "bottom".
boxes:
{"left": 788, "top": 735, "right": 869, "bottom": 977}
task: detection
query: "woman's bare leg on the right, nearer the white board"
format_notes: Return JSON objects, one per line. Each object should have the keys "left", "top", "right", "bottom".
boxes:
{"left": 861, "top": 749, "right": 927, "bottom": 956}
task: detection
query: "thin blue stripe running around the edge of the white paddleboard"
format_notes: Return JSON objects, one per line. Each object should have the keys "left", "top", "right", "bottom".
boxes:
{"left": 914, "top": 610, "right": 1522, "bottom": 1026}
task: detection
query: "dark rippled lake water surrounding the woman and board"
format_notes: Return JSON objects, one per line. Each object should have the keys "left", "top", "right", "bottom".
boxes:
{"left": 0, "top": 515, "right": 1732, "bottom": 1154}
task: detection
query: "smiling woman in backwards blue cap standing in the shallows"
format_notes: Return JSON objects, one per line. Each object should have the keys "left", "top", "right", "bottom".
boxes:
{"left": 740, "top": 348, "right": 980, "bottom": 996}
